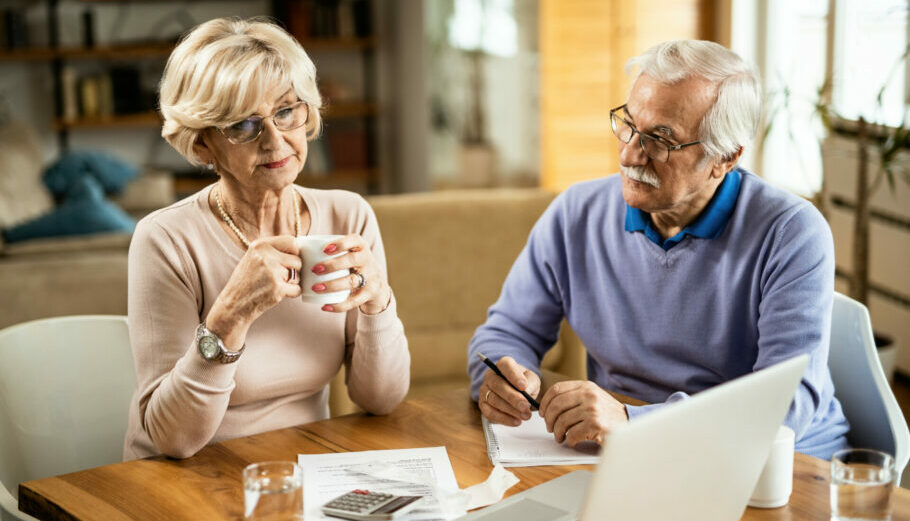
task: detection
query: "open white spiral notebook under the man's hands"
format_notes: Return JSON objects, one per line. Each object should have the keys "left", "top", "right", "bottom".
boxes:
{"left": 483, "top": 412, "right": 600, "bottom": 467}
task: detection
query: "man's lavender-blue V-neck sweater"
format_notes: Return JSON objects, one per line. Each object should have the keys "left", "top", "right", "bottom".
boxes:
{"left": 468, "top": 170, "right": 849, "bottom": 459}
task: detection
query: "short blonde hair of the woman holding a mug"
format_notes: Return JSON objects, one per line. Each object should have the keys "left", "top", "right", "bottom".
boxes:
{"left": 159, "top": 17, "right": 322, "bottom": 165}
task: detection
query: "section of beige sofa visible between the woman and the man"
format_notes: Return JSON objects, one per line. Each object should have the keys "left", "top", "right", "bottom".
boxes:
{"left": 330, "top": 189, "right": 585, "bottom": 414}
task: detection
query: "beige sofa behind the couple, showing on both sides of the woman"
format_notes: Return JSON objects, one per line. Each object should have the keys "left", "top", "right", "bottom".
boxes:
{"left": 0, "top": 189, "right": 584, "bottom": 414}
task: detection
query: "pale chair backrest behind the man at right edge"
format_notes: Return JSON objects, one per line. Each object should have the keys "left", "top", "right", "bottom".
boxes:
{"left": 828, "top": 293, "right": 910, "bottom": 483}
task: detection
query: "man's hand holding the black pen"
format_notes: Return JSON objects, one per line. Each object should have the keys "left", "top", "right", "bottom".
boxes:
{"left": 477, "top": 356, "right": 540, "bottom": 427}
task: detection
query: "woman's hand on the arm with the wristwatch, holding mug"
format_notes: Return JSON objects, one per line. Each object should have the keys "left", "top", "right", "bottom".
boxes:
{"left": 206, "top": 235, "right": 303, "bottom": 349}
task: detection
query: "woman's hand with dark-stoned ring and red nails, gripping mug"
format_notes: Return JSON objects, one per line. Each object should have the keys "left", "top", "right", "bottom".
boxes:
{"left": 312, "top": 233, "right": 392, "bottom": 315}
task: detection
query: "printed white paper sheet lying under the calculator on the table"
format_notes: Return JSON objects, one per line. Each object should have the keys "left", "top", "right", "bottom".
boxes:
{"left": 297, "top": 447, "right": 466, "bottom": 520}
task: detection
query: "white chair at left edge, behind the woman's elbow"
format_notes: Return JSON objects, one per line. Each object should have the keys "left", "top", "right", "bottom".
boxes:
{"left": 0, "top": 315, "right": 136, "bottom": 521}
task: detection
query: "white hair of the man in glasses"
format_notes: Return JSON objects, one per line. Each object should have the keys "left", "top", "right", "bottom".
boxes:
{"left": 626, "top": 40, "right": 762, "bottom": 158}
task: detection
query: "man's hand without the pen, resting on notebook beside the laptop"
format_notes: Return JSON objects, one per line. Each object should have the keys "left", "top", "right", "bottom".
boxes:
{"left": 540, "top": 380, "right": 629, "bottom": 447}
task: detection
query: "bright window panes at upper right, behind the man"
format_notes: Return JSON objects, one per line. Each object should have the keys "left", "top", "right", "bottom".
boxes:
{"left": 732, "top": 0, "right": 910, "bottom": 195}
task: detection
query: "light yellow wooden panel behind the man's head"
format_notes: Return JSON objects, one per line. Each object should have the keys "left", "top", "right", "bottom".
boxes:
{"left": 540, "top": 0, "right": 716, "bottom": 190}
